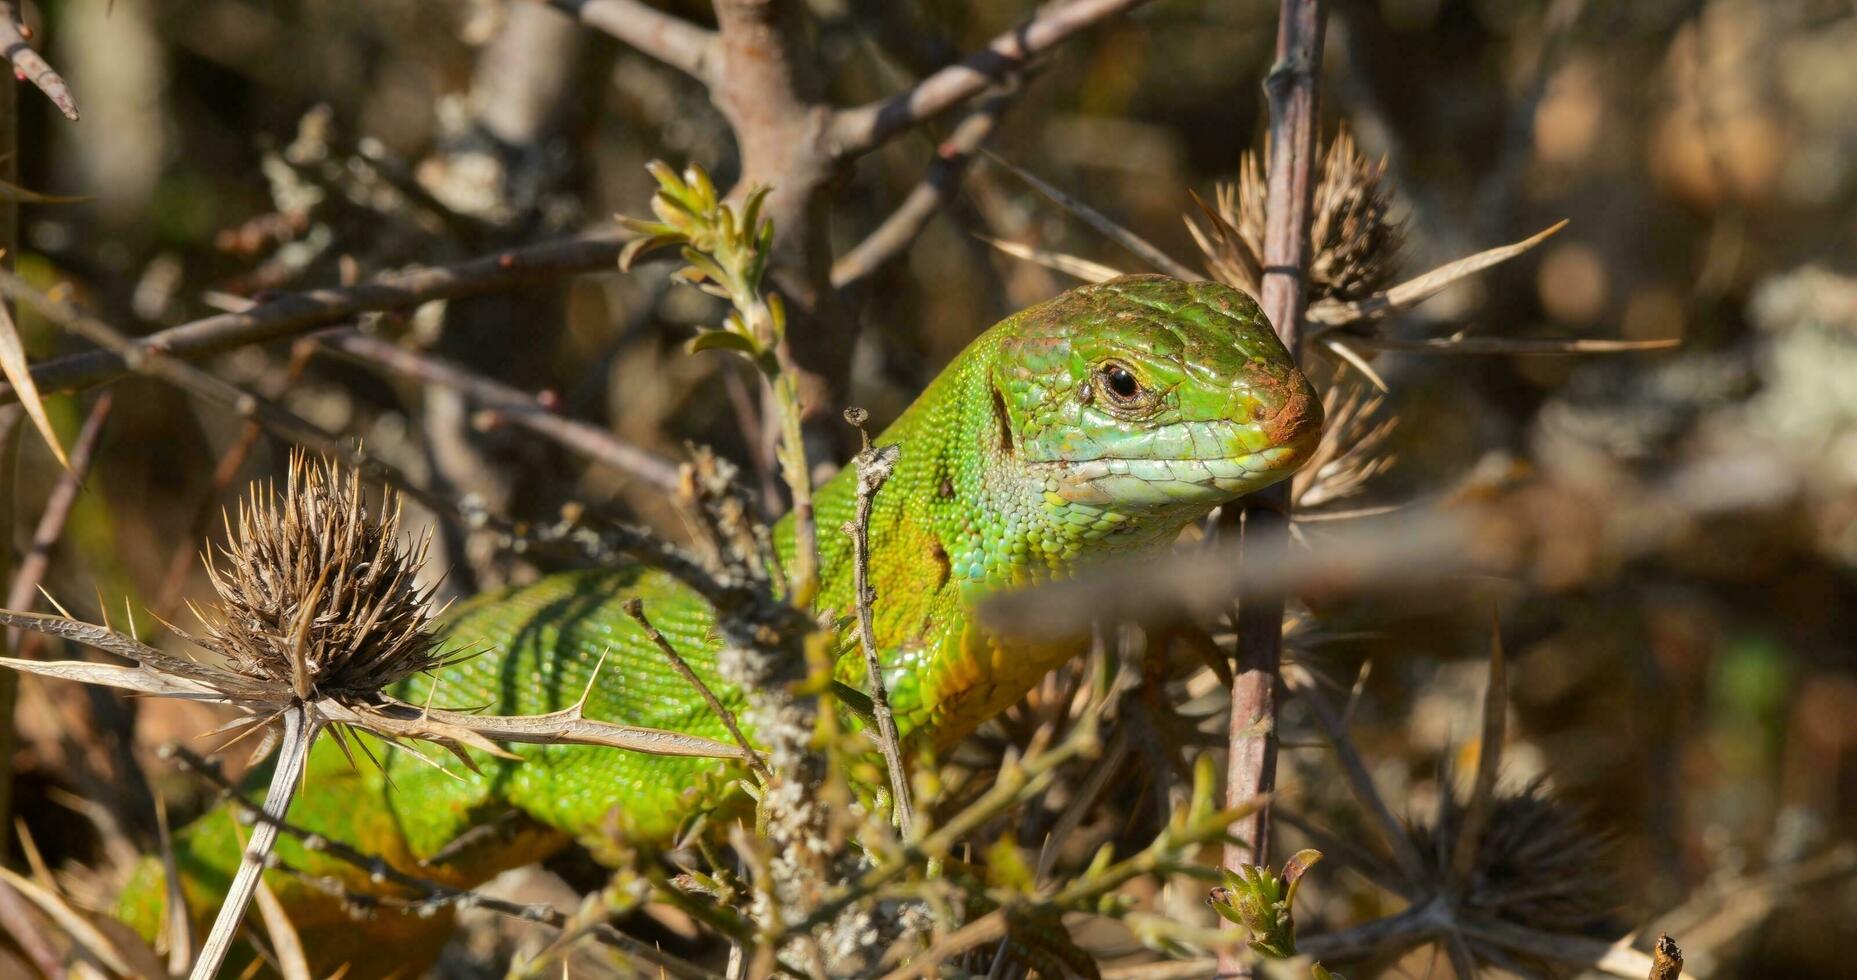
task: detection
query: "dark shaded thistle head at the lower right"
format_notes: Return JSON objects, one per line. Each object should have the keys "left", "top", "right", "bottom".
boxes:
{"left": 1411, "top": 780, "right": 1617, "bottom": 934}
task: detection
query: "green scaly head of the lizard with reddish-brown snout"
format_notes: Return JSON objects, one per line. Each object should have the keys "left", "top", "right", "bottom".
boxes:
{"left": 992, "top": 275, "right": 1322, "bottom": 523}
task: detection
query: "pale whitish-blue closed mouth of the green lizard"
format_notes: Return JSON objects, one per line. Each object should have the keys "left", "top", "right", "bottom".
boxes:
{"left": 1049, "top": 445, "right": 1307, "bottom": 507}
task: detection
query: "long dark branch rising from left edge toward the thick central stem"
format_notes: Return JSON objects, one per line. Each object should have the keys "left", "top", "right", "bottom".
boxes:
{"left": 0, "top": 234, "right": 624, "bottom": 403}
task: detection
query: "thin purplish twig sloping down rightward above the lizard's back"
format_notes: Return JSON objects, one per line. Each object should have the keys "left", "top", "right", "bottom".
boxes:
{"left": 316, "top": 330, "right": 678, "bottom": 490}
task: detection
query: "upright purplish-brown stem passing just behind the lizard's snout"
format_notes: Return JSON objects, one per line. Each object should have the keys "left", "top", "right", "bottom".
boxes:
{"left": 1218, "top": 0, "right": 1329, "bottom": 976}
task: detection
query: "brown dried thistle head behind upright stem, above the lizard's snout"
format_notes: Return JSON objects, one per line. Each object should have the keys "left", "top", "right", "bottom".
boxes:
{"left": 1187, "top": 130, "right": 1406, "bottom": 303}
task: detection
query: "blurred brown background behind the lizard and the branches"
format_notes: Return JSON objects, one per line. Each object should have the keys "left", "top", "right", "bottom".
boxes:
{"left": 13, "top": 0, "right": 1857, "bottom": 978}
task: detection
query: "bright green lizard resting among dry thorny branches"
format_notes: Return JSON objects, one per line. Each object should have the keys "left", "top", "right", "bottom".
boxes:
{"left": 123, "top": 277, "right": 1322, "bottom": 976}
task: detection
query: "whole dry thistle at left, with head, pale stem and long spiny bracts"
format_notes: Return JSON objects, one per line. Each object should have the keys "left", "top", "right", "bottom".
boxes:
{"left": 0, "top": 453, "right": 735, "bottom": 980}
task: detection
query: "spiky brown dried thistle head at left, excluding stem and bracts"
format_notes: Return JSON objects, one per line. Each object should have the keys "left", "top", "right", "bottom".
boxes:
{"left": 195, "top": 453, "right": 446, "bottom": 700}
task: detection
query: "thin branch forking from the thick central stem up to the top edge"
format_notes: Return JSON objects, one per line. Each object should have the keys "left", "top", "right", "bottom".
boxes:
{"left": 830, "top": 0, "right": 1148, "bottom": 158}
